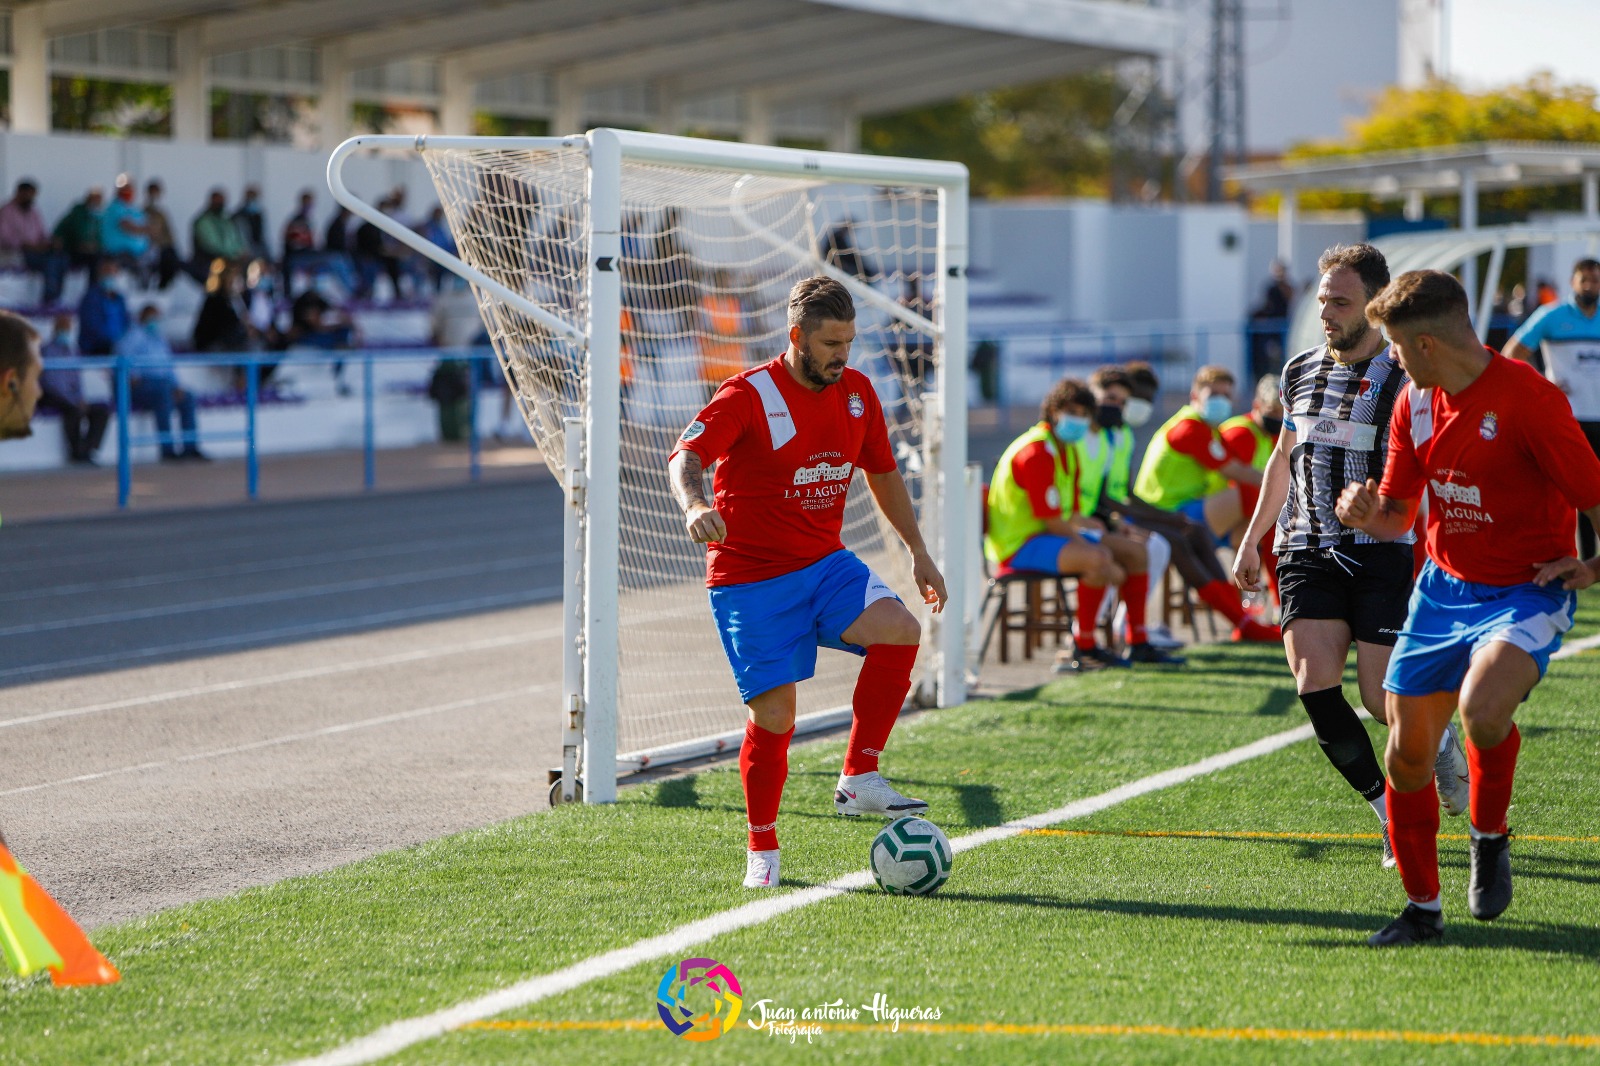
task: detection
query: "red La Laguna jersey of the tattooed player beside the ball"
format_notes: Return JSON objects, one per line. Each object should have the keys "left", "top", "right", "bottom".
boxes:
{"left": 677, "top": 359, "right": 894, "bottom": 586}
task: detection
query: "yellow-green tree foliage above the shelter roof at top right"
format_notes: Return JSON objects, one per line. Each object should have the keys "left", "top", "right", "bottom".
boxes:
{"left": 1285, "top": 74, "right": 1600, "bottom": 222}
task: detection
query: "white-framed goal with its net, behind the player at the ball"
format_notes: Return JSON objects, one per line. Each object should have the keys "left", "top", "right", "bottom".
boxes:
{"left": 328, "top": 130, "right": 976, "bottom": 802}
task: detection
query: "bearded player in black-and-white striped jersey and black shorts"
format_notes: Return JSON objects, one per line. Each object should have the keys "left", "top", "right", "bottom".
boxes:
{"left": 1234, "top": 245, "right": 1467, "bottom": 866}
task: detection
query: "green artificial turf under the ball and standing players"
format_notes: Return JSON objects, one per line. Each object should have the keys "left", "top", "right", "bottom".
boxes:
{"left": 0, "top": 594, "right": 1600, "bottom": 1063}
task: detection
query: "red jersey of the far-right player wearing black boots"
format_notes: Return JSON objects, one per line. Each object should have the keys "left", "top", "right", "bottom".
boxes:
{"left": 1379, "top": 355, "right": 1600, "bottom": 586}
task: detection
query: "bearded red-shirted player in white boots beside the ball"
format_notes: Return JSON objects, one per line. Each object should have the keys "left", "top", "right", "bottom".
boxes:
{"left": 669, "top": 277, "right": 946, "bottom": 888}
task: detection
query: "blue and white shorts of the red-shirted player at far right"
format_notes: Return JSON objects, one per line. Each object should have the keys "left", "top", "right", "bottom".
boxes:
{"left": 1384, "top": 560, "right": 1578, "bottom": 696}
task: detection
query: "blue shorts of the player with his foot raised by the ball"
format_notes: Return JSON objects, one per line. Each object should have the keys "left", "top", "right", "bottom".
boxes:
{"left": 709, "top": 549, "right": 902, "bottom": 703}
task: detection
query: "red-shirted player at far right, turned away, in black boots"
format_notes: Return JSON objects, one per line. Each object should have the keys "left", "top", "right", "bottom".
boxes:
{"left": 1338, "top": 271, "right": 1600, "bottom": 948}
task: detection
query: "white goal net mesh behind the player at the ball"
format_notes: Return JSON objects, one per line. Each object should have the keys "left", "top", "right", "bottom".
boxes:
{"left": 422, "top": 149, "right": 942, "bottom": 752}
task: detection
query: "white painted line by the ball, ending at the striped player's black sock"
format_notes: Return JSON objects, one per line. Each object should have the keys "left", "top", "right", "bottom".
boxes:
{"left": 290, "top": 725, "right": 1312, "bottom": 1066}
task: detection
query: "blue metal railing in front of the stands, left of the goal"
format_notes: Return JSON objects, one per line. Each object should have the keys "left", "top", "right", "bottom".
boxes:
{"left": 46, "top": 347, "right": 496, "bottom": 509}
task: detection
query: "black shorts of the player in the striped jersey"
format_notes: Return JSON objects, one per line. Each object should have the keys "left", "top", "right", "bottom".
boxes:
{"left": 1278, "top": 544, "right": 1411, "bottom": 647}
